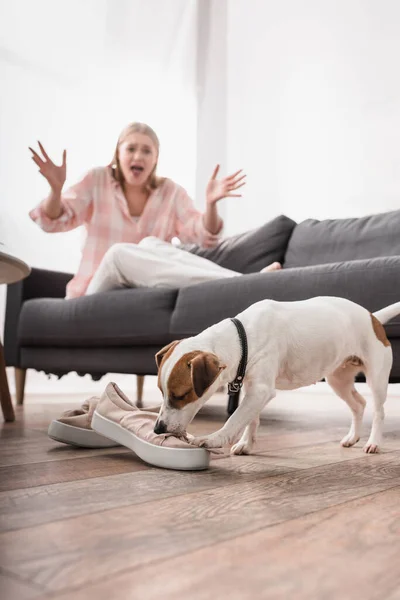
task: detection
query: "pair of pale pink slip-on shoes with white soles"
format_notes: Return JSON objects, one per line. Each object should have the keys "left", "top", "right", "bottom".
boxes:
{"left": 48, "top": 383, "right": 210, "bottom": 471}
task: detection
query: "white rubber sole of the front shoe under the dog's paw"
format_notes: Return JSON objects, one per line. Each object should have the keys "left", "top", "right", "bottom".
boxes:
{"left": 92, "top": 411, "right": 210, "bottom": 471}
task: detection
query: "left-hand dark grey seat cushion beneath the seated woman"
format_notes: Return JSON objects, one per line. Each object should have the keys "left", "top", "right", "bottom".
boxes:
{"left": 19, "top": 288, "right": 177, "bottom": 348}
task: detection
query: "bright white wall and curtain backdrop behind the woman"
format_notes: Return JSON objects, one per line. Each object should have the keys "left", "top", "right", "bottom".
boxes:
{"left": 0, "top": 0, "right": 400, "bottom": 392}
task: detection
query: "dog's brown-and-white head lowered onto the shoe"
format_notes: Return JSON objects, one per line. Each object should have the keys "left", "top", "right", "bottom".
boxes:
{"left": 154, "top": 341, "right": 225, "bottom": 435}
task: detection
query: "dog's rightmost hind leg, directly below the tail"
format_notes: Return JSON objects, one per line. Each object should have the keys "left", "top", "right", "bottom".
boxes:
{"left": 364, "top": 347, "right": 393, "bottom": 454}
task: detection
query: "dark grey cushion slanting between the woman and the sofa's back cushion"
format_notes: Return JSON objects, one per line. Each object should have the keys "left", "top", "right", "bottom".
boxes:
{"left": 181, "top": 215, "right": 296, "bottom": 273}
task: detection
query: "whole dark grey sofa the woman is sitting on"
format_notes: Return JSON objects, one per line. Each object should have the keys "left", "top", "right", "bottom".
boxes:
{"left": 4, "top": 211, "right": 400, "bottom": 402}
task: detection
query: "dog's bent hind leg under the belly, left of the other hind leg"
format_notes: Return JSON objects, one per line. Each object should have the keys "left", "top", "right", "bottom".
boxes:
{"left": 326, "top": 363, "right": 366, "bottom": 448}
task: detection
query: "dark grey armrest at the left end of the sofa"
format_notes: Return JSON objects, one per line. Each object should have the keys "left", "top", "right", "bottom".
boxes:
{"left": 4, "top": 268, "right": 72, "bottom": 367}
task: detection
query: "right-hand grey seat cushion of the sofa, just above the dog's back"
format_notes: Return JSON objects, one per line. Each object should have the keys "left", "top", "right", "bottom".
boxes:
{"left": 171, "top": 256, "right": 400, "bottom": 337}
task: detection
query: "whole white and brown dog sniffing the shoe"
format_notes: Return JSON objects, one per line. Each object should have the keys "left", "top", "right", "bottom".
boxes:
{"left": 154, "top": 297, "right": 400, "bottom": 454}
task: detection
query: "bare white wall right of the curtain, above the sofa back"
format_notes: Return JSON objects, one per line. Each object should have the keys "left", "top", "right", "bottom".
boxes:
{"left": 225, "top": 0, "right": 400, "bottom": 233}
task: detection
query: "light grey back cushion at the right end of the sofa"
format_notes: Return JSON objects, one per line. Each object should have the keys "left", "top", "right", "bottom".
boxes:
{"left": 284, "top": 210, "right": 400, "bottom": 268}
